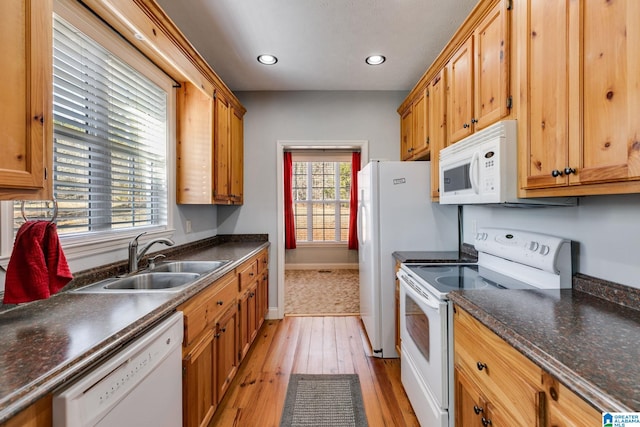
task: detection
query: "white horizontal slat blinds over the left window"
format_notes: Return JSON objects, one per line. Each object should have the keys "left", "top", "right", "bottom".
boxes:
{"left": 18, "top": 16, "right": 168, "bottom": 234}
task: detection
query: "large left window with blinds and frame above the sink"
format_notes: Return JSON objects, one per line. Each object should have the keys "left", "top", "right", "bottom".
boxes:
{"left": 3, "top": 0, "right": 175, "bottom": 260}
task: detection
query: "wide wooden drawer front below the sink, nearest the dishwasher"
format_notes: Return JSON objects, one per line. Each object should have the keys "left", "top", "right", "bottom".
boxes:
{"left": 178, "top": 272, "right": 238, "bottom": 346}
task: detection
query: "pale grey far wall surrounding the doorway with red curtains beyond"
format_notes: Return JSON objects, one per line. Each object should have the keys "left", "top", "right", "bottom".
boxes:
{"left": 218, "top": 91, "right": 406, "bottom": 307}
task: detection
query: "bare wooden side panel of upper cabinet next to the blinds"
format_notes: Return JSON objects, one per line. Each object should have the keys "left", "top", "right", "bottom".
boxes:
{"left": 176, "top": 82, "right": 214, "bottom": 204}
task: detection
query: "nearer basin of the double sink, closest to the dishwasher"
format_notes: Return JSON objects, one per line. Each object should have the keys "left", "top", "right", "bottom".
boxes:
{"left": 74, "top": 272, "right": 200, "bottom": 293}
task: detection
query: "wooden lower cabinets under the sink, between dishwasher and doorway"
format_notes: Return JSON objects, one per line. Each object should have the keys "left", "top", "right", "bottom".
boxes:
{"left": 178, "top": 249, "right": 268, "bottom": 427}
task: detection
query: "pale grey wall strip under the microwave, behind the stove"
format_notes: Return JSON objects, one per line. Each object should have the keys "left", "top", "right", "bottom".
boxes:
{"left": 463, "top": 194, "right": 640, "bottom": 288}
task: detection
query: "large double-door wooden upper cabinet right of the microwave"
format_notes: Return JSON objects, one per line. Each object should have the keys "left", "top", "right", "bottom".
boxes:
{"left": 518, "top": 0, "right": 640, "bottom": 195}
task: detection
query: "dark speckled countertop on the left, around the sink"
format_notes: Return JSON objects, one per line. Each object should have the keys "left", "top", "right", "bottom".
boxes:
{"left": 0, "top": 235, "right": 269, "bottom": 423}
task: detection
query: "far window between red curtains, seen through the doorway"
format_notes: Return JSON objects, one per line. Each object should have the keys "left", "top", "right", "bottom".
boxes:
{"left": 292, "top": 154, "right": 351, "bottom": 243}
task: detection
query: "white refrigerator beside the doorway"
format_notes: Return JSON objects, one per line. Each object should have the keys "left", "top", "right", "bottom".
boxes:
{"left": 358, "top": 161, "right": 459, "bottom": 357}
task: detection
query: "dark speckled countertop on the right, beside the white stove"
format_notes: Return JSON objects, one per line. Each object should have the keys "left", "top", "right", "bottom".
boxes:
{"left": 449, "top": 286, "right": 640, "bottom": 412}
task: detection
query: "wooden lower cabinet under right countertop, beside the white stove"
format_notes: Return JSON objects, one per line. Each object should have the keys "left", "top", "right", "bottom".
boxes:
{"left": 453, "top": 306, "right": 601, "bottom": 427}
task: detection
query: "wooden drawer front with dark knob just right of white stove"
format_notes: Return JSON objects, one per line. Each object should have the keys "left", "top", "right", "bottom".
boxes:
{"left": 454, "top": 308, "right": 544, "bottom": 426}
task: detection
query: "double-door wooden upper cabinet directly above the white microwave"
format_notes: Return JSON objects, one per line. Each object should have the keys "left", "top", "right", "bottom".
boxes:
{"left": 447, "top": 0, "right": 509, "bottom": 142}
